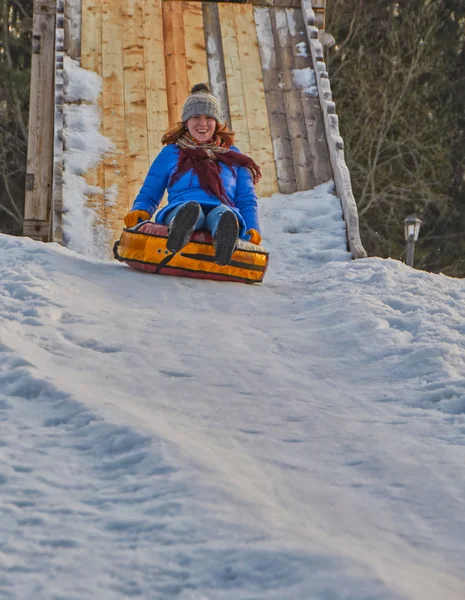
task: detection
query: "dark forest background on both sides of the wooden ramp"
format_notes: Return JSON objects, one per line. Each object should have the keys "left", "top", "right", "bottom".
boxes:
{"left": 0, "top": 0, "right": 465, "bottom": 277}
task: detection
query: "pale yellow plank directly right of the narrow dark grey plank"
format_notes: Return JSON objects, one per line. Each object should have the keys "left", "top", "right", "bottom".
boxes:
{"left": 218, "top": 3, "right": 251, "bottom": 155}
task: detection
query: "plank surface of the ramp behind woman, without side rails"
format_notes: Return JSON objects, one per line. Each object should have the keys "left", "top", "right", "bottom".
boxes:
{"left": 81, "top": 0, "right": 332, "bottom": 244}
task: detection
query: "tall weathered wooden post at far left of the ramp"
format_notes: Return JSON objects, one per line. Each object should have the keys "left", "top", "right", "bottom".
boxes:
{"left": 23, "top": 0, "right": 56, "bottom": 241}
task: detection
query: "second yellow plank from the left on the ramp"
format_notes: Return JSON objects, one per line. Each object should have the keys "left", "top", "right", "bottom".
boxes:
{"left": 102, "top": 0, "right": 128, "bottom": 237}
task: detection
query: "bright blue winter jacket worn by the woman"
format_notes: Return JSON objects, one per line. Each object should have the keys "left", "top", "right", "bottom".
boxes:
{"left": 132, "top": 144, "right": 260, "bottom": 239}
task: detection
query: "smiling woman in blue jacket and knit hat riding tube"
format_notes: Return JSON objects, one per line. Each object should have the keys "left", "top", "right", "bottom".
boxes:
{"left": 124, "top": 83, "right": 261, "bottom": 265}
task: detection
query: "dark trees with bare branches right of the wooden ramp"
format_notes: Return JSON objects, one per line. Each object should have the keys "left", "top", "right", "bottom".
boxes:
{"left": 327, "top": 0, "right": 465, "bottom": 275}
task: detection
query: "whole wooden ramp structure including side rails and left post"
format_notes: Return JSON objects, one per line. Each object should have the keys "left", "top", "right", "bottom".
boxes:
{"left": 24, "top": 0, "right": 365, "bottom": 257}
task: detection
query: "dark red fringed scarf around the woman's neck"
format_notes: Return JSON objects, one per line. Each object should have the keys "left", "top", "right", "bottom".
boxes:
{"left": 169, "top": 133, "right": 262, "bottom": 206}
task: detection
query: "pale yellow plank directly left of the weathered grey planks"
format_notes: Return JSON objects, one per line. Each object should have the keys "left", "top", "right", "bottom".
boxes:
{"left": 234, "top": 4, "right": 278, "bottom": 196}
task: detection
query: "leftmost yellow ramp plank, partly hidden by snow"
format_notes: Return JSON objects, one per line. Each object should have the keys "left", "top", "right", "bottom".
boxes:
{"left": 81, "top": 0, "right": 105, "bottom": 227}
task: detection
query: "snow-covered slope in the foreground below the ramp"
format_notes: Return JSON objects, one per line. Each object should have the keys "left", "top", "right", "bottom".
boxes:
{"left": 0, "top": 186, "right": 465, "bottom": 600}
